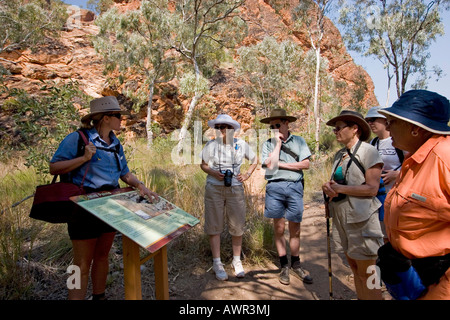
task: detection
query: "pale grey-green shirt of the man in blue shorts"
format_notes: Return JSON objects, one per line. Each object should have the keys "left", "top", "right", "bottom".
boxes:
{"left": 261, "top": 133, "right": 311, "bottom": 181}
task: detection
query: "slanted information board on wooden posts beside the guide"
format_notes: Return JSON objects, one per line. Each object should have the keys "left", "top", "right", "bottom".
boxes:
{"left": 70, "top": 188, "right": 200, "bottom": 300}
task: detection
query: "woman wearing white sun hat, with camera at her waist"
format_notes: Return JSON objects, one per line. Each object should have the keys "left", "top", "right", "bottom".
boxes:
{"left": 200, "top": 114, "right": 257, "bottom": 280}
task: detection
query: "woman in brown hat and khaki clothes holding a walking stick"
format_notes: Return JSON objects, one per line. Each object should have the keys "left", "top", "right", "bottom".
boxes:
{"left": 322, "top": 110, "right": 383, "bottom": 300}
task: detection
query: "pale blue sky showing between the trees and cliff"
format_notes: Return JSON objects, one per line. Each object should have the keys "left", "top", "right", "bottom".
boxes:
{"left": 63, "top": 0, "right": 450, "bottom": 107}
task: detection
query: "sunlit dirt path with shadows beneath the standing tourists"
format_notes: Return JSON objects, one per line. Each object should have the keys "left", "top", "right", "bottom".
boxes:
{"left": 170, "top": 203, "right": 356, "bottom": 300}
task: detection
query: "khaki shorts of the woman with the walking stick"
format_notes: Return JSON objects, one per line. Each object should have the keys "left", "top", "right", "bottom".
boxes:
{"left": 332, "top": 205, "right": 383, "bottom": 260}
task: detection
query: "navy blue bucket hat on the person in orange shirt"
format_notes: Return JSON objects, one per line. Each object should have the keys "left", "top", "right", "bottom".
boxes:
{"left": 378, "top": 90, "right": 450, "bottom": 134}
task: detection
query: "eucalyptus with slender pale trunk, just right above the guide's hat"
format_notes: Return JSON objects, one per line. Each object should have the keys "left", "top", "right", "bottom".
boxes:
{"left": 93, "top": 0, "right": 176, "bottom": 147}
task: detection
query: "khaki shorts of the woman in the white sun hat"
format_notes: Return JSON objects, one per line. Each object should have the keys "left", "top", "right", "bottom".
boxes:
{"left": 204, "top": 183, "right": 246, "bottom": 236}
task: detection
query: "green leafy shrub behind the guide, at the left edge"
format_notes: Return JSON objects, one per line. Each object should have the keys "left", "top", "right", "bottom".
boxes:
{"left": 1, "top": 82, "right": 88, "bottom": 173}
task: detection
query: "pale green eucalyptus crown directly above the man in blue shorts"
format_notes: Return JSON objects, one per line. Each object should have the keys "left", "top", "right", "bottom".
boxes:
{"left": 236, "top": 36, "right": 304, "bottom": 116}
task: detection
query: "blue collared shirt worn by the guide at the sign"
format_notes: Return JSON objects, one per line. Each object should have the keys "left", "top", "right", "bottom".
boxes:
{"left": 51, "top": 128, "right": 130, "bottom": 189}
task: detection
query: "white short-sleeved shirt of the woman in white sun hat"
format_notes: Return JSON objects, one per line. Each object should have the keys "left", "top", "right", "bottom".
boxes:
{"left": 201, "top": 138, "right": 256, "bottom": 186}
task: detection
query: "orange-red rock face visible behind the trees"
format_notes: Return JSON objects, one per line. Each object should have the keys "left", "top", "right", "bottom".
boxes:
{"left": 0, "top": 0, "right": 377, "bottom": 136}
